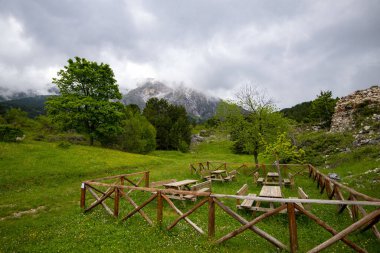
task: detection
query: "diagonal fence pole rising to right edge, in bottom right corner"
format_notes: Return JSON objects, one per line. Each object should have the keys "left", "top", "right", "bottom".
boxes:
{"left": 308, "top": 209, "right": 380, "bottom": 253}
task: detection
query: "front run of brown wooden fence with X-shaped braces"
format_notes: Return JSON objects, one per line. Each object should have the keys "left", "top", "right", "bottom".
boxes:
{"left": 80, "top": 166, "right": 380, "bottom": 252}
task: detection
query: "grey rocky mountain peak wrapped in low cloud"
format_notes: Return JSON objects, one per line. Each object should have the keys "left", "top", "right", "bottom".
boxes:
{"left": 122, "top": 79, "right": 220, "bottom": 121}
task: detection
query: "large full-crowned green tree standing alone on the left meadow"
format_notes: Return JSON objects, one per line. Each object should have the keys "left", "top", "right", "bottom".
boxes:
{"left": 46, "top": 57, "right": 123, "bottom": 145}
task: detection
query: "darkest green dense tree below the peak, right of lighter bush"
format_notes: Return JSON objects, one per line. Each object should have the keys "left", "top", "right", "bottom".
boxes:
{"left": 143, "top": 98, "right": 191, "bottom": 150}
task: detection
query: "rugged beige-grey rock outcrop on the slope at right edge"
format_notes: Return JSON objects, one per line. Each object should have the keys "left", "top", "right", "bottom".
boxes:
{"left": 330, "top": 85, "right": 380, "bottom": 132}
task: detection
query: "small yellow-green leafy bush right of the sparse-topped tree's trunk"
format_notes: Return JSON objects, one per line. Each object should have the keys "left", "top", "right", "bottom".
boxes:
{"left": 265, "top": 133, "right": 305, "bottom": 164}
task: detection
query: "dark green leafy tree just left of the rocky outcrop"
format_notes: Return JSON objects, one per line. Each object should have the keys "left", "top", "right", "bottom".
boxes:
{"left": 311, "top": 91, "right": 338, "bottom": 127}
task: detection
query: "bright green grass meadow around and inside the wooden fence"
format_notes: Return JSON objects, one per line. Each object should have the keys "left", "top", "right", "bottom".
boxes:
{"left": 0, "top": 136, "right": 380, "bottom": 252}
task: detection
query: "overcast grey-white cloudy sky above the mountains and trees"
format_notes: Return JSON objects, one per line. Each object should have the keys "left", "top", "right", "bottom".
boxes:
{"left": 0, "top": 0, "right": 380, "bottom": 107}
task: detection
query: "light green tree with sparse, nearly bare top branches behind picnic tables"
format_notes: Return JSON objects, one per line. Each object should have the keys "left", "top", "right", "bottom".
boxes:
{"left": 220, "top": 85, "right": 289, "bottom": 164}
